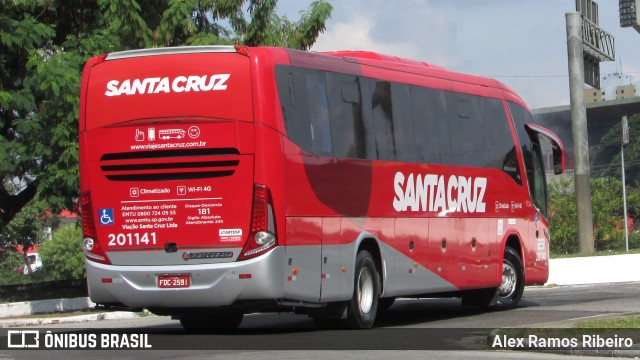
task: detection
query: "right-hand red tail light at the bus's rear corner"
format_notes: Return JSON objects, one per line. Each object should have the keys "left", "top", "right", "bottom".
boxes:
{"left": 238, "top": 184, "right": 278, "bottom": 260}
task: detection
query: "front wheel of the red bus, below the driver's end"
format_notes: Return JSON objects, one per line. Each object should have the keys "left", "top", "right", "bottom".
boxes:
{"left": 497, "top": 246, "right": 524, "bottom": 309}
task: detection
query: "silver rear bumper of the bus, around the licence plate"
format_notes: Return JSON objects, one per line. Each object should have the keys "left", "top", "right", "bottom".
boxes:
{"left": 86, "top": 247, "right": 285, "bottom": 308}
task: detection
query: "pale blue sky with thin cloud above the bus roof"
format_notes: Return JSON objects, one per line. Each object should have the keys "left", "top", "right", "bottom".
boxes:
{"left": 278, "top": 0, "right": 640, "bottom": 109}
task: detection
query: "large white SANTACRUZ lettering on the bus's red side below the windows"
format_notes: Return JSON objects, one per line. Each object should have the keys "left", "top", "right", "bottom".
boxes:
{"left": 393, "top": 172, "right": 487, "bottom": 213}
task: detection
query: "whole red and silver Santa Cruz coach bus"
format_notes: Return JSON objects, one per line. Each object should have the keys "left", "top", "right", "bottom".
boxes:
{"left": 80, "top": 46, "right": 564, "bottom": 329}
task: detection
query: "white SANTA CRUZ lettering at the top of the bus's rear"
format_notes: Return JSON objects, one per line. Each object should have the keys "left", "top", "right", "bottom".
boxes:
{"left": 104, "top": 74, "right": 231, "bottom": 96}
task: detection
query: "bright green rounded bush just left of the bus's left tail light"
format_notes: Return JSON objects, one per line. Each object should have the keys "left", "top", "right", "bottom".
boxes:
{"left": 38, "top": 224, "right": 85, "bottom": 280}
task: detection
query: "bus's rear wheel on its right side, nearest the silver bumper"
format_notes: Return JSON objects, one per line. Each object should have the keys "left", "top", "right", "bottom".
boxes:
{"left": 347, "top": 250, "right": 380, "bottom": 329}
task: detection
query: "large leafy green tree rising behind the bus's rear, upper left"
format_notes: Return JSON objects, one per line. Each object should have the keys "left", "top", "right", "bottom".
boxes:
{"left": 0, "top": 0, "right": 332, "bottom": 232}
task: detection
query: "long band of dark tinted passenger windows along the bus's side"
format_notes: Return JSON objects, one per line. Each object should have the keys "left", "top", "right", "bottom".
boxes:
{"left": 276, "top": 66, "right": 520, "bottom": 183}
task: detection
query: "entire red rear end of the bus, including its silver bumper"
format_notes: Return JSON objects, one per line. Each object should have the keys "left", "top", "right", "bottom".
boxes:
{"left": 80, "top": 47, "right": 284, "bottom": 324}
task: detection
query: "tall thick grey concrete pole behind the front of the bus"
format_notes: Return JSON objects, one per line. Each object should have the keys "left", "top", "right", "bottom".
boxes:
{"left": 565, "top": 12, "right": 594, "bottom": 253}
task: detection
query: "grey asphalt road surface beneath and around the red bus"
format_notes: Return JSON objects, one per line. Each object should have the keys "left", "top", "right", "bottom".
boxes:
{"left": 0, "top": 283, "right": 640, "bottom": 360}
